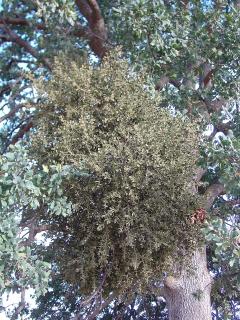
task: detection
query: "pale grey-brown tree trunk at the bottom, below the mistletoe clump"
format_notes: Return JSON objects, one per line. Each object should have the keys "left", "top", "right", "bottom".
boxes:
{"left": 164, "top": 248, "right": 212, "bottom": 320}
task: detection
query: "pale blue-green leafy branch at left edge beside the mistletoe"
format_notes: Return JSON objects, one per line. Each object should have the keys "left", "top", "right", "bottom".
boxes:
{"left": 0, "top": 144, "right": 72, "bottom": 294}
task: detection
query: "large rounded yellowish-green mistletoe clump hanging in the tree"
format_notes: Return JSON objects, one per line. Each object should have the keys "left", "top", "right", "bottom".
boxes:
{"left": 33, "top": 55, "right": 201, "bottom": 293}
